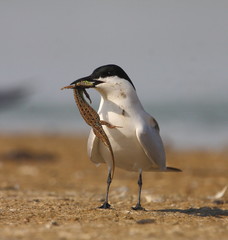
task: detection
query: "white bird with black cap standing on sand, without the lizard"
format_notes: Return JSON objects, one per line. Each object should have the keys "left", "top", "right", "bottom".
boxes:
{"left": 72, "top": 64, "right": 181, "bottom": 210}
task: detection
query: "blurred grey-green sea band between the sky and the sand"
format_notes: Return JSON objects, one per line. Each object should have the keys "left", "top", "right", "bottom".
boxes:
{"left": 0, "top": 96, "right": 228, "bottom": 149}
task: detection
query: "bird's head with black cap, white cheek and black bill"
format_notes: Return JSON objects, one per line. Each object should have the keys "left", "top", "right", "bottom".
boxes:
{"left": 71, "top": 64, "right": 135, "bottom": 99}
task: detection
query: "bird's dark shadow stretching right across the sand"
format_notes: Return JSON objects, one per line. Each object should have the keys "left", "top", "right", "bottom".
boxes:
{"left": 155, "top": 207, "right": 228, "bottom": 218}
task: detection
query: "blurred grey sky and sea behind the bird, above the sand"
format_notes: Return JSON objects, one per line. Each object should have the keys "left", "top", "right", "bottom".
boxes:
{"left": 0, "top": 0, "right": 228, "bottom": 149}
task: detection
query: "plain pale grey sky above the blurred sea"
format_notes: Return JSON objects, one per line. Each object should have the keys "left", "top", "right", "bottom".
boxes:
{"left": 0, "top": 0, "right": 228, "bottom": 102}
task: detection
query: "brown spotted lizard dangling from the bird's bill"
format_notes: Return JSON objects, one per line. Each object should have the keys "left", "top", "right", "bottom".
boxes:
{"left": 61, "top": 82, "right": 116, "bottom": 178}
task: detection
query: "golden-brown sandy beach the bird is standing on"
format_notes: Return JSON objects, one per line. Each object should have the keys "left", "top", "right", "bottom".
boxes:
{"left": 0, "top": 134, "right": 228, "bottom": 240}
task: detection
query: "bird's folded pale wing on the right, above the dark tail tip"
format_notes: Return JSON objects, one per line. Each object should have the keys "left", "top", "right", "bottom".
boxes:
{"left": 136, "top": 117, "right": 166, "bottom": 170}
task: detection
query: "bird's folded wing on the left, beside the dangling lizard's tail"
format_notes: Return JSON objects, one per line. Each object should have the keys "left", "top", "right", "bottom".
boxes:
{"left": 87, "top": 130, "right": 105, "bottom": 164}
